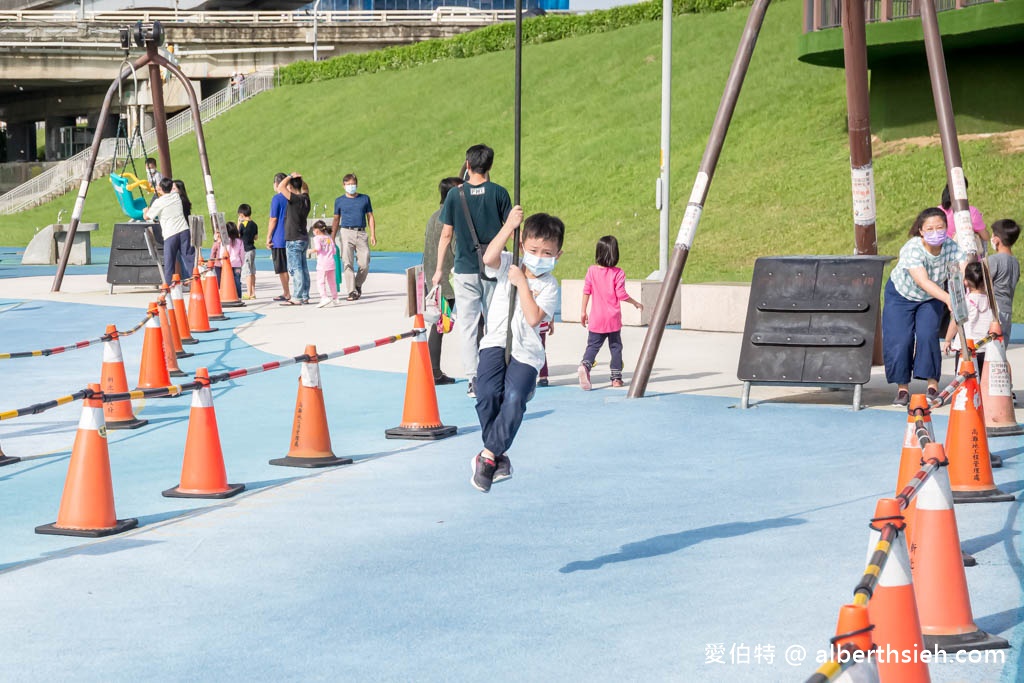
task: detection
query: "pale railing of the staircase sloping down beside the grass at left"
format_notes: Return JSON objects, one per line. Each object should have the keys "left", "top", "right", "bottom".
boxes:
{"left": 0, "top": 71, "right": 276, "bottom": 215}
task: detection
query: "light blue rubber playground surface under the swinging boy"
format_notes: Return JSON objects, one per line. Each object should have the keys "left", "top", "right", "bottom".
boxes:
{"left": 0, "top": 294, "right": 1024, "bottom": 682}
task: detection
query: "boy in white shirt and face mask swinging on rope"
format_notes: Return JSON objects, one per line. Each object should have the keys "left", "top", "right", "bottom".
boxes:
{"left": 470, "top": 206, "right": 565, "bottom": 493}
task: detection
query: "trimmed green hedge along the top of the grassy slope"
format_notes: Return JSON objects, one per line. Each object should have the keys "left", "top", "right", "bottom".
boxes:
{"left": 280, "top": 0, "right": 736, "bottom": 84}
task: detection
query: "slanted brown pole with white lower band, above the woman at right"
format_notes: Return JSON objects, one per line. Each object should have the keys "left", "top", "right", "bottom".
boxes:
{"left": 921, "top": 0, "right": 978, "bottom": 261}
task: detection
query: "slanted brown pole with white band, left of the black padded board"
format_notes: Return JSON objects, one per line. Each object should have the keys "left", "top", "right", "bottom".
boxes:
{"left": 628, "top": 0, "right": 771, "bottom": 398}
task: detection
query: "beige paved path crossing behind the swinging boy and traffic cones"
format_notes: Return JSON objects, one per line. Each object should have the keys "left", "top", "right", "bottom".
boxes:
{"left": 0, "top": 273, "right": 1024, "bottom": 414}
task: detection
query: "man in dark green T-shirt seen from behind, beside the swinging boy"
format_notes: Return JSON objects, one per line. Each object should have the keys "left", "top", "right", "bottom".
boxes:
{"left": 431, "top": 144, "right": 512, "bottom": 397}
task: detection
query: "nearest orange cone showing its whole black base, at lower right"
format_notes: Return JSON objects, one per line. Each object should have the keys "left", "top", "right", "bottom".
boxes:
{"left": 910, "top": 443, "right": 1010, "bottom": 650}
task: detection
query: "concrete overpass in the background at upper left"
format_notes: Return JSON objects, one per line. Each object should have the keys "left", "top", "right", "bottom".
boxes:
{"left": 0, "top": 8, "right": 513, "bottom": 161}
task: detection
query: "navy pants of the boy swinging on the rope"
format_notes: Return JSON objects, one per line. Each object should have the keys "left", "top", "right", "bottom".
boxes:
{"left": 476, "top": 347, "right": 537, "bottom": 456}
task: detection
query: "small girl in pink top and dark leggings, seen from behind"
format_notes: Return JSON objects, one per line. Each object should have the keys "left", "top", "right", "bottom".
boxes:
{"left": 577, "top": 234, "right": 643, "bottom": 391}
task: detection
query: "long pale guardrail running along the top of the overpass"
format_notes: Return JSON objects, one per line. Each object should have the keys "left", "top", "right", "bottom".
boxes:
{"left": 0, "top": 7, "right": 528, "bottom": 25}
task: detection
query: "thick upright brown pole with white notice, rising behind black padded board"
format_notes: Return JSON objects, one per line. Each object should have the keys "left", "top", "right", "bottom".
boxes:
{"left": 843, "top": 0, "right": 879, "bottom": 256}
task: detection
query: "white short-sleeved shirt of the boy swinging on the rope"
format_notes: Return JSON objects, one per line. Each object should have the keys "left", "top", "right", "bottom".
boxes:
{"left": 480, "top": 252, "right": 558, "bottom": 372}
